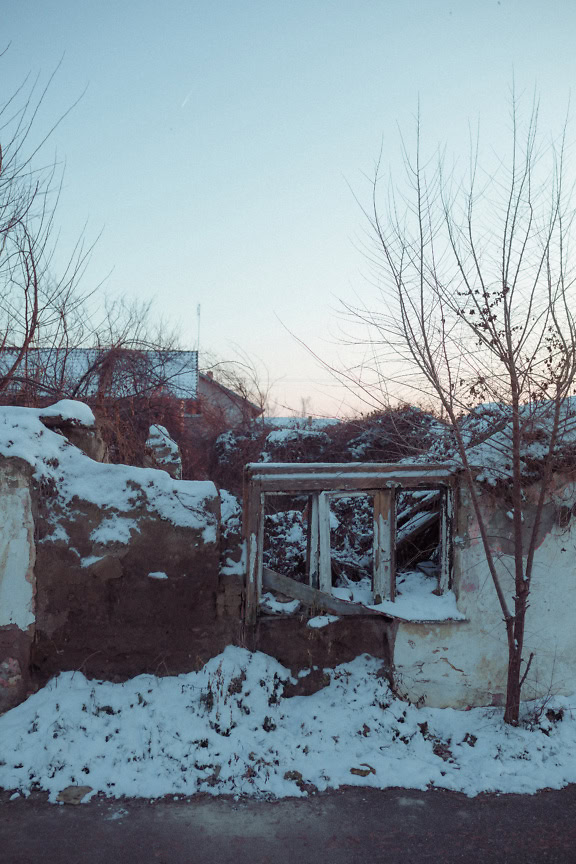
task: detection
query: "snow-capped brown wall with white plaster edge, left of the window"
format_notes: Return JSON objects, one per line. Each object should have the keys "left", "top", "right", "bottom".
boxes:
{"left": 0, "top": 401, "right": 232, "bottom": 711}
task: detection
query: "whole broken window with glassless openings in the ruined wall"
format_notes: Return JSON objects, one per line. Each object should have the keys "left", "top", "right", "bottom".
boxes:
{"left": 244, "top": 463, "right": 454, "bottom": 620}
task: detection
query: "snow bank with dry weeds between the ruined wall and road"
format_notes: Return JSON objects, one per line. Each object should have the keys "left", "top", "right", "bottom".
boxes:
{"left": 0, "top": 647, "right": 576, "bottom": 801}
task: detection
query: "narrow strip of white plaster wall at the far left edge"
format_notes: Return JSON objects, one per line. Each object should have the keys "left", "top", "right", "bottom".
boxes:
{"left": 0, "top": 459, "right": 35, "bottom": 713}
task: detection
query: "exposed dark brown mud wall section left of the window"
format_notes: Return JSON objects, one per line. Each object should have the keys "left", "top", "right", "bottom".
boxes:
{"left": 32, "top": 482, "right": 239, "bottom": 681}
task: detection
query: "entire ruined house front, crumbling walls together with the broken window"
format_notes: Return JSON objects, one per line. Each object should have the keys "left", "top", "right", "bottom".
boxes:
{"left": 0, "top": 400, "right": 576, "bottom": 711}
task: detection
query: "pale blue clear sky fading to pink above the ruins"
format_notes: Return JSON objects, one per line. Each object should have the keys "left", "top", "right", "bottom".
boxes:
{"left": 0, "top": 0, "right": 576, "bottom": 416}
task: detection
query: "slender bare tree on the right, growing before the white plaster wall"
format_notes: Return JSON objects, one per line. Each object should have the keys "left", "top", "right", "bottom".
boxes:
{"left": 346, "top": 96, "right": 576, "bottom": 724}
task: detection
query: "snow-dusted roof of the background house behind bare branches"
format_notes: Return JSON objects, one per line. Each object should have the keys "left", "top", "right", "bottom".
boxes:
{"left": 0, "top": 348, "right": 198, "bottom": 399}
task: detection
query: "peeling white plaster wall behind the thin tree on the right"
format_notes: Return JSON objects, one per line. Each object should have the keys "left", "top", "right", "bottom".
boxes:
{"left": 394, "top": 477, "right": 576, "bottom": 708}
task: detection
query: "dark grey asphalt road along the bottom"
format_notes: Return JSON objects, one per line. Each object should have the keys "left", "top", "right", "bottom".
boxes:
{"left": 0, "top": 786, "right": 576, "bottom": 864}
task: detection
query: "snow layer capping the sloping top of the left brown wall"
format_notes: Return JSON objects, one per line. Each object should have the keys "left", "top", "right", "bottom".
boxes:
{"left": 0, "top": 403, "right": 218, "bottom": 543}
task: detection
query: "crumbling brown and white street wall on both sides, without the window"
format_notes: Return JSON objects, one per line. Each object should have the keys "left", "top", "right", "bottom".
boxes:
{"left": 0, "top": 403, "right": 576, "bottom": 711}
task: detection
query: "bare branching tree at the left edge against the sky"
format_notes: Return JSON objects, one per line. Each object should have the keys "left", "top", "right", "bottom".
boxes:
{"left": 0, "top": 51, "right": 91, "bottom": 392}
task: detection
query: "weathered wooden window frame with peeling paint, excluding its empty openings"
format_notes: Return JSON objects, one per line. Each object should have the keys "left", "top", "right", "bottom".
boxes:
{"left": 243, "top": 462, "right": 458, "bottom": 624}
